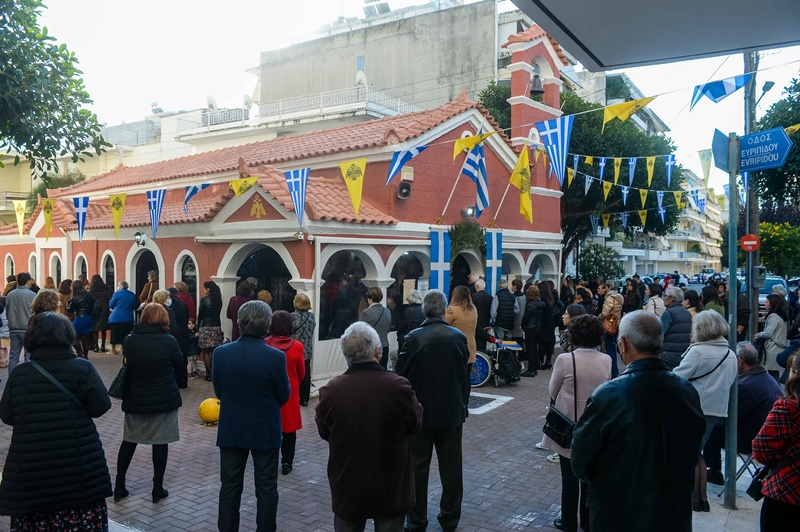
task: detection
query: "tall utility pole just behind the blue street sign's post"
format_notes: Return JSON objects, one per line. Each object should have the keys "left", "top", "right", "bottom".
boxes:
{"left": 744, "top": 52, "right": 761, "bottom": 338}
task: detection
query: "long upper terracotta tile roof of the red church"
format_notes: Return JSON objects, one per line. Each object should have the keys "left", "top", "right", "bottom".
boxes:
{"left": 51, "top": 92, "right": 511, "bottom": 197}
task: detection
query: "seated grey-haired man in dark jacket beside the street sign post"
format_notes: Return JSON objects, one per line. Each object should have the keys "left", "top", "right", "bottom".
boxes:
{"left": 701, "top": 342, "right": 781, "bottom": 486}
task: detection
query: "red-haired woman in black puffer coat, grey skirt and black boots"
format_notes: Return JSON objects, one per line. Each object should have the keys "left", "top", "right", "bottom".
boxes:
{"left": 114, "top": 303, "right": 184, "bottom": 503}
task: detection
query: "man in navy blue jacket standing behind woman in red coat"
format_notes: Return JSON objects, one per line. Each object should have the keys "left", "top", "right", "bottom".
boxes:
{"left": 212, "top": 301, "right": 289, "bottom": 532}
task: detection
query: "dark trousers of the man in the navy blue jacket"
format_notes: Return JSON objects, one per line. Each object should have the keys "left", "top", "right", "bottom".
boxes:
{"left": 217, "top": 447, "right": 278, "bottom": 532}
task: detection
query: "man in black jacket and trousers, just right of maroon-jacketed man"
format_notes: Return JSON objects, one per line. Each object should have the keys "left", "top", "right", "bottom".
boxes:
{"left": 397, "top": 290, "right": 470, "bottom": 532}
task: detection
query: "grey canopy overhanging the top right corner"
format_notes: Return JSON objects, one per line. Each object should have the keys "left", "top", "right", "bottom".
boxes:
{"left": 512, "top": 0, "right": 800, "bottom": 72}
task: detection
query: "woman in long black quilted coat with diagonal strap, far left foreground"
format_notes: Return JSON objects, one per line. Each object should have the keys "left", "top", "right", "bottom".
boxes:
{"left": 0, "top": 312, "right": 111, "bottom": 530}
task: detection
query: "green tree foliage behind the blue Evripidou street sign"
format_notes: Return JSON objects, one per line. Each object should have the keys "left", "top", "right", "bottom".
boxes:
{"left": 750, "top": 78, "right": 800, "bottom": 205}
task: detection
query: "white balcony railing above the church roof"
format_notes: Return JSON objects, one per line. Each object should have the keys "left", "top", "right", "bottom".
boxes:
{"left": 259, "top": 87, "right": 420, "bottom": 120}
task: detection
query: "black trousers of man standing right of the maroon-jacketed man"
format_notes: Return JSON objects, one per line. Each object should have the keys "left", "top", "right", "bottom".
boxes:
{"left": 406, "top": 425, "right": 464, "bottom": 532}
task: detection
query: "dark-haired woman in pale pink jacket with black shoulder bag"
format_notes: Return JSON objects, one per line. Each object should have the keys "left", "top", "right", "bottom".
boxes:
{"left": 543, "top": 315, "right": 611, "bottom": 530}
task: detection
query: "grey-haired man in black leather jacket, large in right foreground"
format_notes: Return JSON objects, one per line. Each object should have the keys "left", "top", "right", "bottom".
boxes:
{"left": 571, "top": 310, "right": 705, "bottom": 532}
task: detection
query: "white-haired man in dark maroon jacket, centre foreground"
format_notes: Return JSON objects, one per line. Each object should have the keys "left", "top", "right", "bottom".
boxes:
{"left": 316, "top": 322, "right": 422, "bottom": 532}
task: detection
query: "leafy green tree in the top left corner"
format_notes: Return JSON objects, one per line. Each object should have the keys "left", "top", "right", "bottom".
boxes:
{"left": 0, "top": 0, "right": 110, "bottom": 183}
